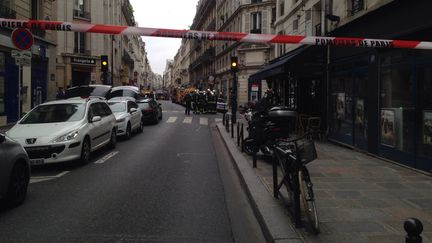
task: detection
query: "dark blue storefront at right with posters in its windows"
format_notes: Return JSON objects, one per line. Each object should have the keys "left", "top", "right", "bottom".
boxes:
{"left": 327, "top": 1, "right": 432, "bottom": 171}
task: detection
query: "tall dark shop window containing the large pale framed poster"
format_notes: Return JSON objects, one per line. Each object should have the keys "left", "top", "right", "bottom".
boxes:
{"left": 380, "top": 65, "right": 415, "bottom": 152}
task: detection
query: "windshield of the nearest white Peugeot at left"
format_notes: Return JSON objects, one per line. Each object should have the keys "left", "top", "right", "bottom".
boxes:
{"left": 20, "top": 104, "right": 85, "bottom": 124}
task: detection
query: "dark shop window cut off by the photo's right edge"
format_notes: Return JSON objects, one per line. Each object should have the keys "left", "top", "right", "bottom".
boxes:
{"left": 416, "top": 67, "right": 432, "bottom": 160}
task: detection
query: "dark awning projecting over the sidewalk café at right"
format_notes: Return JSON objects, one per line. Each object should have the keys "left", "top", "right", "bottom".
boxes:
{"left": 249, "top": 46, "right": 310, "bottom": 82}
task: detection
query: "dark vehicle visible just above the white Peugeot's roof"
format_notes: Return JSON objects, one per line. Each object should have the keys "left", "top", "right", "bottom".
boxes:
{"left": 64, "top": 84, "right": 111, "bottom": 99}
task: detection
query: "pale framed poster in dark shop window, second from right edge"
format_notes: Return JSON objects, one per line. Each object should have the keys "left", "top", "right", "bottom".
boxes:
{"left": 381, "top": 109, "right": 396, "bottom": 147}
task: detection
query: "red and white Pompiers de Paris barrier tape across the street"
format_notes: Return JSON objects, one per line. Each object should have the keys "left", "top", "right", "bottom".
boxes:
{"left": 0, "top": 18, "right": 432, "bottom": 49}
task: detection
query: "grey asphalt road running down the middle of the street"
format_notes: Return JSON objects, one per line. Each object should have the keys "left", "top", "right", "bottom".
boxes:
{"left": 0, "top": 101, "right": 264, "bottom": 242}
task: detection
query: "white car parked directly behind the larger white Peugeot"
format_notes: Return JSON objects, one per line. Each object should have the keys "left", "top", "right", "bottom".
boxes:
{"left": 108, "top": 97, "right": 143, "bottom": 139}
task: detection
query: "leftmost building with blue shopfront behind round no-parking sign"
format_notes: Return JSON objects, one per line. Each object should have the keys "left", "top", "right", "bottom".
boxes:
{"left": 0, "top": 0, "right": 56, "bottom": 126}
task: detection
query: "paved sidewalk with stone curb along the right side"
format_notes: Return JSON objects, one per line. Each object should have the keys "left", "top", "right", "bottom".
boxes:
{"left": 217, "top": 116, "right": 432, "bottom": 243}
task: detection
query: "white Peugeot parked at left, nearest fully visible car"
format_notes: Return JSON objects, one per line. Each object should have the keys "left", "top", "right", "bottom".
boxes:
{"left": 7, "top": 98, "right": 117, "bottom": 165}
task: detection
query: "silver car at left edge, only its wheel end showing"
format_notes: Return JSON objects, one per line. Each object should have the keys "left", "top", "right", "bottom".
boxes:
{"left": 0, "top": 134, "right": 30, "bottom": 206}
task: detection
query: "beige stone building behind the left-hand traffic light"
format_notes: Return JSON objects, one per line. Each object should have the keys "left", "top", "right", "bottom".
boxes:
{"left": 55, "top": 0, "right": 149, "bottom": 88}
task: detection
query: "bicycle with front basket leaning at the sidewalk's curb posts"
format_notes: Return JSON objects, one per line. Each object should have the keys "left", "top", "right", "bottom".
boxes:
{"left": 272, "top": 134, "right": 320, "bottom": 234}
